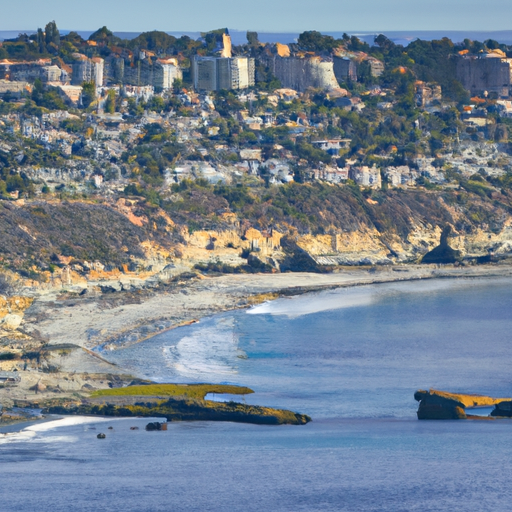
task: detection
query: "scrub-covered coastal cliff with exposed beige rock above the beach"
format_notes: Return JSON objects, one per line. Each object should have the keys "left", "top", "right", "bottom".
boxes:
{"left": 0, "top": 185, "right": 512, "bottom": 290}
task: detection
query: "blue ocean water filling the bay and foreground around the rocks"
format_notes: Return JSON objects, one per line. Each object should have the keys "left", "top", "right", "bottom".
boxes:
{"left": 0, "top": 280, "right": 512, "bottom": 512}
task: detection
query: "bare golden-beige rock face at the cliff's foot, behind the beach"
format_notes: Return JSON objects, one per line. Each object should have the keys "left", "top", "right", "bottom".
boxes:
{"left": 169, "top": 219, "right": 512, "bottom": 266}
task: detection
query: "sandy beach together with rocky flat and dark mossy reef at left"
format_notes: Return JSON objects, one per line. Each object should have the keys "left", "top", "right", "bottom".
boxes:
{"left": 0, "top": 264, "right": 512, "bottom": 424}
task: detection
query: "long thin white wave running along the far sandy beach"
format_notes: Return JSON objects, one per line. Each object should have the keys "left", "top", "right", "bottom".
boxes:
{"left": 247, "top": 279, "right": 488, "bottom": 318}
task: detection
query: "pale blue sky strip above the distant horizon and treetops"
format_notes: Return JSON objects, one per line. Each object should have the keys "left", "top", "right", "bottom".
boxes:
{"left": 0, "top": 0, "right": 512, "bottom": 32}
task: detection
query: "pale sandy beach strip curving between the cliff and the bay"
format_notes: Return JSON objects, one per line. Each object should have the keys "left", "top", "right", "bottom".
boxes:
{"left": 24, "top": 265, "right": 512, "bottom": 350}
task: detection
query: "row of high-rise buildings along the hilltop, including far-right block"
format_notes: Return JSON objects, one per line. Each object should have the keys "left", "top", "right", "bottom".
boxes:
{"left": 0, "top": 34, "right": 512, "bottom": 108}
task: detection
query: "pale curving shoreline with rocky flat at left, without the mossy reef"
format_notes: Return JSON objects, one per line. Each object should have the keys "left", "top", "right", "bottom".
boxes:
{"left": 0, "top": 265, "right": 512, "bottom": 425}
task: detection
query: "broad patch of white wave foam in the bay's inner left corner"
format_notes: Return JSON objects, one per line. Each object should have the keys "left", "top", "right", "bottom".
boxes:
{"left": 163, "top": 317, "right": 243, "bottom": 379}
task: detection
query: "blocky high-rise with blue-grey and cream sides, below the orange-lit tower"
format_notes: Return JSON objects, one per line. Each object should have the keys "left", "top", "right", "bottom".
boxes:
{"left": 192, "top": 56, "right": 255, "bottom": 91}
